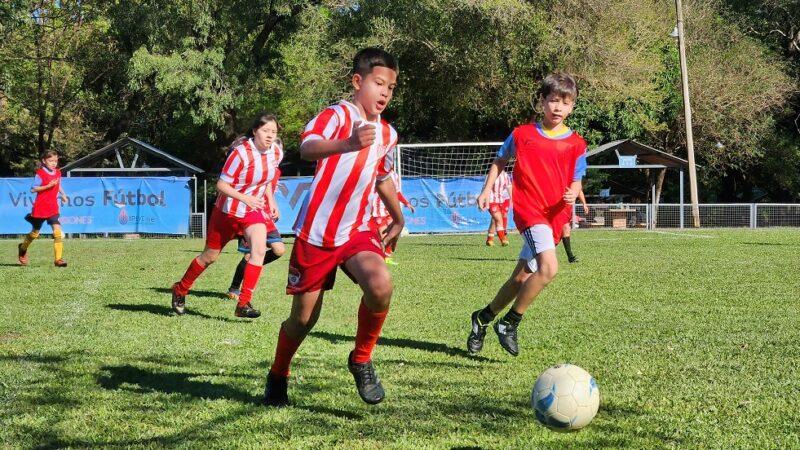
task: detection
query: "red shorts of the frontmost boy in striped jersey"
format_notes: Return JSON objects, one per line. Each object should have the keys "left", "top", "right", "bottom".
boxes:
{"left": 286, "top": 231, "right": 386, "bottom": 295}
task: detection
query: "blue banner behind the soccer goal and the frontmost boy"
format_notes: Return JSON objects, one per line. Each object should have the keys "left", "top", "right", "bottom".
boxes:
{"left": 275, "top": 177, "right": 490, "bottom": 233}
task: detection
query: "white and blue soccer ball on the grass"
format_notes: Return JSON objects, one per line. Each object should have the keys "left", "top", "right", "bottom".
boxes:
{"left": 531, "top": 364, "right": 600, "bottom": 431}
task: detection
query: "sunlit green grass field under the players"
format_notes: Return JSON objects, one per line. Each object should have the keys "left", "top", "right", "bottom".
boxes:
{"left": 0, "top": 230, "right": 800, "bottom": 448}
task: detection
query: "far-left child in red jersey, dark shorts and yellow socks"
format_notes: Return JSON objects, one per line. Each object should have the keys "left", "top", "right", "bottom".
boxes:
{"left": 17, "top": 150, "right": 67, "bottom": 267}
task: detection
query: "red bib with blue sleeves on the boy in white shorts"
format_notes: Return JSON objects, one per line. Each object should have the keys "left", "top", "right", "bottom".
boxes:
{"left": 497, "top": 123, "right": 586, "bottom": 243}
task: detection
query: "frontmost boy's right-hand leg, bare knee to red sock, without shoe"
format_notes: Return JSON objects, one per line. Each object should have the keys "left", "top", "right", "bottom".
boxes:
{"left": 345, "top": 251, "right": 394, "bottom": 364}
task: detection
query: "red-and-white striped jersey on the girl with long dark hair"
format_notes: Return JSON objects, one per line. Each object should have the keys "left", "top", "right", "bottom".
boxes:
{"left": 216, "top": 139, "right": 283, "bottom": 217}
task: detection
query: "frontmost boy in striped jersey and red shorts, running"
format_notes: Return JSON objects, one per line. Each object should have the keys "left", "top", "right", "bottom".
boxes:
{"left": 264, "top": 48, "right": 405, "bottom": 406}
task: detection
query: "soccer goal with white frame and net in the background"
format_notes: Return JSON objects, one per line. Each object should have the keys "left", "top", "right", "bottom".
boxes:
{"left": 395, "top": 142, "right": 506, "bottom": 233}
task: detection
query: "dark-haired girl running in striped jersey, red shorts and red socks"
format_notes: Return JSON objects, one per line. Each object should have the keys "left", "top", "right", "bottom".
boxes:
{"left": 172, "top": 114, "right": 278, "bottom": 318}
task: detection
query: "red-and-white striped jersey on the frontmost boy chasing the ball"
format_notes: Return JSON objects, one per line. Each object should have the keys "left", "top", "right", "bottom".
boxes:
{"left": 294, "top": 100, "right": 398, "bottom": 247}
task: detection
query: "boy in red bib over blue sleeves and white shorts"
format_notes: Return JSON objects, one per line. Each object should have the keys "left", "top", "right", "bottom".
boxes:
{"left": 467, "top": 73, "right": 586, "bottom": 356}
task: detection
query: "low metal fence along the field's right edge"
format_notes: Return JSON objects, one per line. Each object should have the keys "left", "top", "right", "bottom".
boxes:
{"left": 575, "top": 203, "right": 800, "bottom": 229}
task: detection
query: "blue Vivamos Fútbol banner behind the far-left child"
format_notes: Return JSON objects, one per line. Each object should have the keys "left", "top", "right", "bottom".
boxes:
{"left": 0, "top": 177, "right": 191, "bottom": 234}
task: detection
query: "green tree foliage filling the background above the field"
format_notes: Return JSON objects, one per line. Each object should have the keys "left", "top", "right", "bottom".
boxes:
{"left": 0, "top": 0, "right": 800, "bottom": 200}
